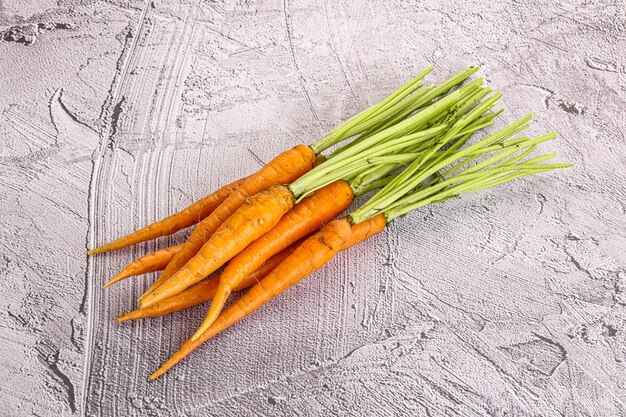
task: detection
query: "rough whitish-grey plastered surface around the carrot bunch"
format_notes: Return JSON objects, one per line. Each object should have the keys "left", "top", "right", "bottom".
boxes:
{"left": 0, "top": 0, "right": 626, "bottom": 416}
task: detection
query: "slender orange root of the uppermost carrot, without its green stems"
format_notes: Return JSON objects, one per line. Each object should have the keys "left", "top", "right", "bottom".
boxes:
{"left": 140, "top": 145, "right": 317, "bottom": 300}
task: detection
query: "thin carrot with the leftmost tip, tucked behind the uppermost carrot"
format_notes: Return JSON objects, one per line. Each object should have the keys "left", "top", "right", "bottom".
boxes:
{"left": 87, "top": 178, "right": 246, "bottom": 255}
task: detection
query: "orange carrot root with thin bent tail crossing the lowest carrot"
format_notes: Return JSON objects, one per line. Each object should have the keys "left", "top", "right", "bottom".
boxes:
{"left": 194, "top": 180, "right": 354, "bottom": 338}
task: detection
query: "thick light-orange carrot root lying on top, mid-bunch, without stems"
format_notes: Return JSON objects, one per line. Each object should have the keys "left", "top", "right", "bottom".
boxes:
{"left": 140, "top": 185, "right": 294, "bottom": 308}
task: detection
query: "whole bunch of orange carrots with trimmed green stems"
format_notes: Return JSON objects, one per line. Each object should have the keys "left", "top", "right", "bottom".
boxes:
{"left": 89, "top": 68, "right": 570, "bottom": 379}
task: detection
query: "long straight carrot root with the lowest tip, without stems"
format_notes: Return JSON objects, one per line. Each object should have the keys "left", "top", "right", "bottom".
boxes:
{"left": 150, "top": 219, "right": 351, "bottom": 380}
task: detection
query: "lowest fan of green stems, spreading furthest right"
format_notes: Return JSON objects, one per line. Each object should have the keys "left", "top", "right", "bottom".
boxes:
{"left": 350, "top": 115, "right": 571, "bottom": 223}
